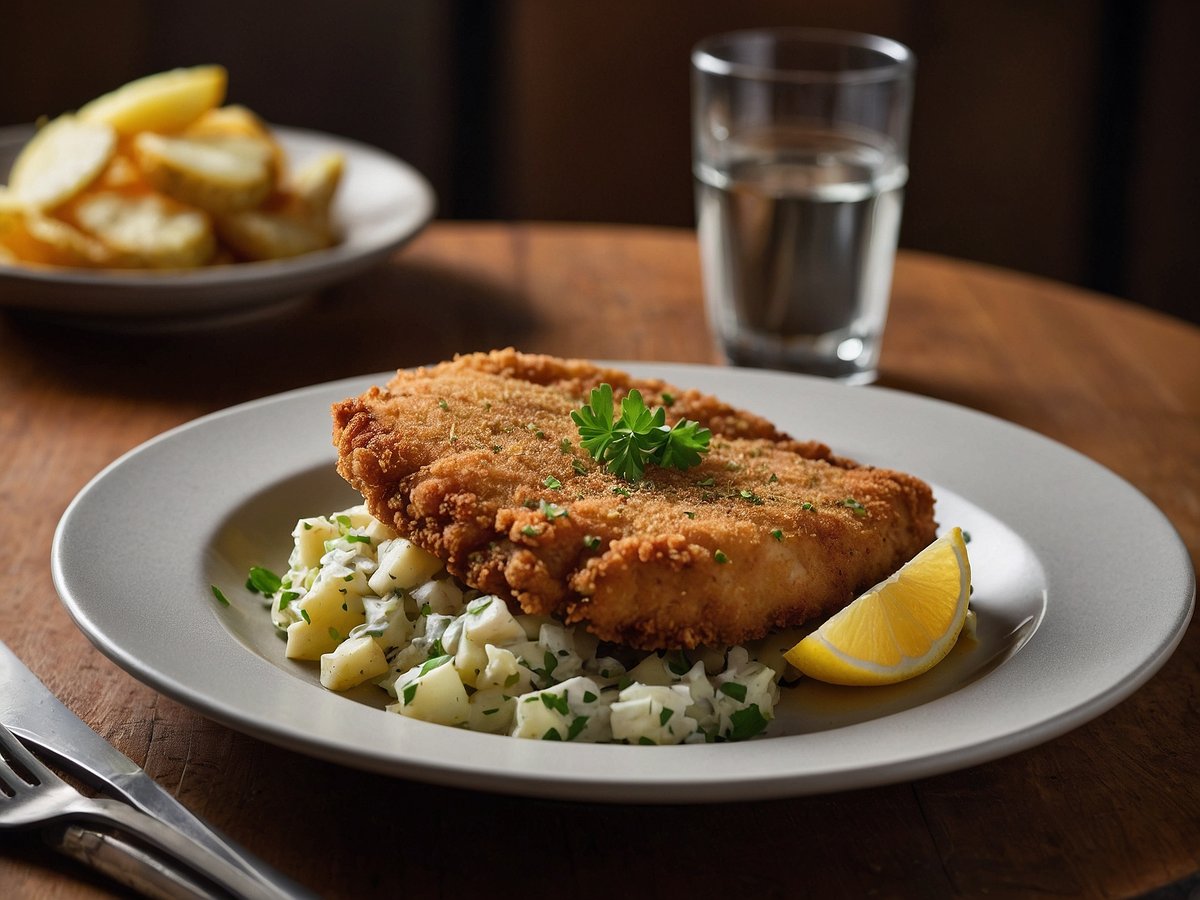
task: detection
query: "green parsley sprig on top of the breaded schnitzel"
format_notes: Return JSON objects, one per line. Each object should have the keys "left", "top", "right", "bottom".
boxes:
{"left": 571, "top": 383, "right": 712, "bottom": 481}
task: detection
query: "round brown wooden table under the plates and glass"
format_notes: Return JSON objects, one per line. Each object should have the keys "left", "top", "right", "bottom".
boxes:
{"left": 0, "top": 223, "right": 1200, "bottom": 898}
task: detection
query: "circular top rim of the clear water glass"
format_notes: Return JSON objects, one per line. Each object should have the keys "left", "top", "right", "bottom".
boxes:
{"left": 691, "top": 28, "right": 917, "bottom": 84}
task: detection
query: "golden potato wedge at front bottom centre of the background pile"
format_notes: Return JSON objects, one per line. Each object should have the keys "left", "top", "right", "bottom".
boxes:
{"left": 72, "top": 191, "right": 216, "bottom": 269}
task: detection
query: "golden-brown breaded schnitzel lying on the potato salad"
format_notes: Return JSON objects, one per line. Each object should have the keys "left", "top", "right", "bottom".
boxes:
{"left": 334, "top": 349, "right": 935, "bottom": 649}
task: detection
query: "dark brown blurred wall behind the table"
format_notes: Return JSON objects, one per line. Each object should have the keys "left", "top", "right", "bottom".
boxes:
{"left": 0, "top": 0, "right": 1200, "bottom": 320}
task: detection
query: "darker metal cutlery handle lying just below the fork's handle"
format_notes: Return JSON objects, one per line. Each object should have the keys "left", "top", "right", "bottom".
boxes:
{"left": 46, "top": 824, "right": 217, "bottom": 900}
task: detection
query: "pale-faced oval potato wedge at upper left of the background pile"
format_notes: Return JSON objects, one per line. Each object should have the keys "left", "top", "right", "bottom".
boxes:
{"left": 8, "top": 114, "right": 116, "bottom": 210}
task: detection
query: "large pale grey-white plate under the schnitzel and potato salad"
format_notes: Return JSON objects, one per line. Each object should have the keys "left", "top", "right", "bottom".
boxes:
{"left": 53, "top": 364, "right": 1195, "bottom": 802}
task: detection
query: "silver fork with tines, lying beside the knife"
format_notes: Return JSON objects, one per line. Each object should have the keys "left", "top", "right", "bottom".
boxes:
{"left": 0, "top": 725, "right": 286, "bottom": 900}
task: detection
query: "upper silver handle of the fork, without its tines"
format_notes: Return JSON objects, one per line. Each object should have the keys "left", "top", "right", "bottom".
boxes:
{"left": 61, "top": 797, "right": 289, "bottom": 900}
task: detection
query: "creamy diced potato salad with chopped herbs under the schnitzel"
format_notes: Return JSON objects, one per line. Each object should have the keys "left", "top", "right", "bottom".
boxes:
{"left": 259, "top": 506, "right": 790, "bottom": 744}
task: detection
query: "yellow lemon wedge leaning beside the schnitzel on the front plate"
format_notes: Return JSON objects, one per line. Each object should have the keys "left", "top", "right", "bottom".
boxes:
{"left": 784, "top": 528, "right": 971, "bottom": 685}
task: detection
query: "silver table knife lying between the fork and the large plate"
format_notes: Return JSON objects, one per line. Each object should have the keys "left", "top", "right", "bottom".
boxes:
{"left": 0, "top": 642, "right": 316, "bottom": 898}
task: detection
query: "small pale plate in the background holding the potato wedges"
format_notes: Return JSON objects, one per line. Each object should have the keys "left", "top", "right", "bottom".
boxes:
{"left": 0, "top": 126, "right": 436, "bottom": 326}
